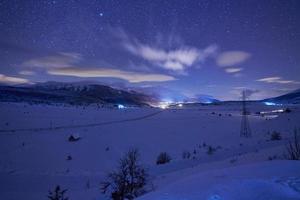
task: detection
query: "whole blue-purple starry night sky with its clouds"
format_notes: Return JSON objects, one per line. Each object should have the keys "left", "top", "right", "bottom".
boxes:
{"left": 0, "top": 0, "right": 300, "bottom": 100}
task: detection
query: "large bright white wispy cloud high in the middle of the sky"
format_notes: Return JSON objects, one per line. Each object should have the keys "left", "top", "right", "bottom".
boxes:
{"left": 115, "top": 29, "right": 218, "bottom": 73}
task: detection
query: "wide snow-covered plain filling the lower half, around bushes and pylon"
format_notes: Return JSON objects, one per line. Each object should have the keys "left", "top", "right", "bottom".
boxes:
{"left": 0, "top": 103, "right": 300, "bottom": 200}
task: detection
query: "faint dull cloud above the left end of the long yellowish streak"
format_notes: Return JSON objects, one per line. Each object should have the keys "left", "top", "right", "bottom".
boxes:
{"left": 22, "top": 52, "right": 82, "bottom": 69}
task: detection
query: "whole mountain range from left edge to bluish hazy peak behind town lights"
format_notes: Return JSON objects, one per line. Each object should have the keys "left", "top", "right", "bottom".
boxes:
{"left": 0, "top": 82, "right": 219, "bottom": 106}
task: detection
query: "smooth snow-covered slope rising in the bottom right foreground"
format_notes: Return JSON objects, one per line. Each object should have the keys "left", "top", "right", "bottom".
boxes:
{"left": 138, "top": 161, "right": 300, "bottom": 200}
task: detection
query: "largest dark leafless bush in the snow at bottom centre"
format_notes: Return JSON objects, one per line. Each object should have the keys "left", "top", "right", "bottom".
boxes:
{"left": 101, "top": 149, "right": 148, "bottom": 200}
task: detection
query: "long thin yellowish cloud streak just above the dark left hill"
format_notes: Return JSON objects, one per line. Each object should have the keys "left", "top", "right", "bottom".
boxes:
{"left": 48, "top": 67, "right": 176, "bottom": 83}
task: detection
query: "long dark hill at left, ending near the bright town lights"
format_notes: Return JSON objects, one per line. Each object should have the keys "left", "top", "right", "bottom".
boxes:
{"left": 0, "top": 82, "right": 155, "bottom": 106}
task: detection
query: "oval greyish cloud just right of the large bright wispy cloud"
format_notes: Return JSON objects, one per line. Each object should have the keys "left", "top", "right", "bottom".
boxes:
{"left": 216, "top": 51, "right": 251, "bottom": 67}
